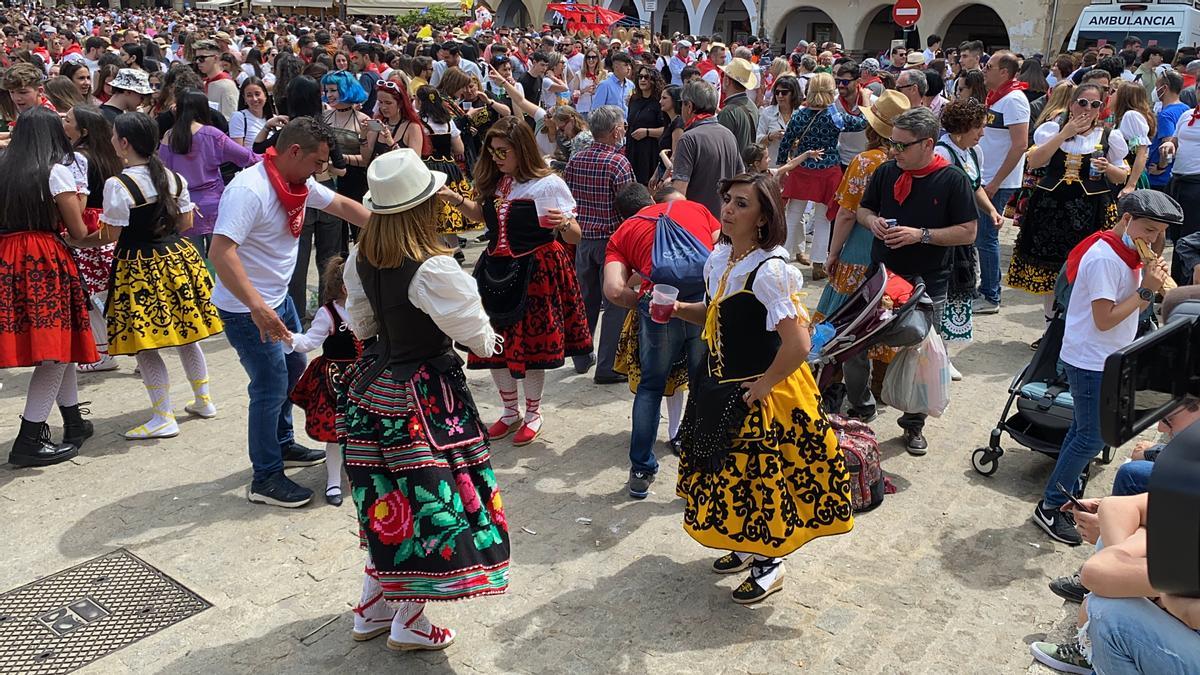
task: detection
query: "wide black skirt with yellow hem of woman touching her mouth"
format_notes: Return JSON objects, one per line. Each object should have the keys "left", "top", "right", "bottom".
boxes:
{"left": 1008, "top": 184, "right": 1117, "bottom": 295}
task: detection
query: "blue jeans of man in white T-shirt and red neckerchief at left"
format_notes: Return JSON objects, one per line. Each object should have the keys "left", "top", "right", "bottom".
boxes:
{"left": 220, "top": 298, "right": 306, "bottom": 480}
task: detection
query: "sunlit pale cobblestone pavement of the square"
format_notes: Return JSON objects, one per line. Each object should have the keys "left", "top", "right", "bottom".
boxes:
{"left": 0, "top": 233, "right": 1124, "bottom": 674}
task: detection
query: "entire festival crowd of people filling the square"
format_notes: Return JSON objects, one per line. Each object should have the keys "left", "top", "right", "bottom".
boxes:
{"left": 0, "top": 3, "right": 1200, "bottom": 673}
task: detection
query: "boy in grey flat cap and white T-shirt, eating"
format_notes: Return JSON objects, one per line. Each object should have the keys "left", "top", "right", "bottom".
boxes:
{"left": 1033, "top": 190, "right": 1183, "bottom": 546}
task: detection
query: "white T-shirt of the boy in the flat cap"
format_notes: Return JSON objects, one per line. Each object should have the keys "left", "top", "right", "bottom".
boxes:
{"left": 1060, "top": 240, "right": 1141, "bottom": 372}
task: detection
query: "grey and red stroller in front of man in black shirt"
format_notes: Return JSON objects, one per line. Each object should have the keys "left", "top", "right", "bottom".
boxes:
{"left": 809, "top": 264, "right": 932, "bottom": 403}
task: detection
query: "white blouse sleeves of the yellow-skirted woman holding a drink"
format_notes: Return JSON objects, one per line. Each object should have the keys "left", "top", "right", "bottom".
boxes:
{"left": 704, "top": 244, "right": 809, "bottom": 330}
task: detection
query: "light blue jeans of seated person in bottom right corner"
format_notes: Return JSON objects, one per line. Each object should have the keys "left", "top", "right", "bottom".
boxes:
{"left": 1087, "top": 593, "right": 1200, "bottom": 675}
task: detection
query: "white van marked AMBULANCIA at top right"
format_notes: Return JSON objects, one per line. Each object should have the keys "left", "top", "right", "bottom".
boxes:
{"left": 1067, "top": 0, "right": 1200, "bottom": 52}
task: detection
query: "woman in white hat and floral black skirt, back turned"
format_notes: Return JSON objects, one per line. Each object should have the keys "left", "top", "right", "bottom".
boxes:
{"left": 337, "top": 148, "right": 509, "bottom": 650}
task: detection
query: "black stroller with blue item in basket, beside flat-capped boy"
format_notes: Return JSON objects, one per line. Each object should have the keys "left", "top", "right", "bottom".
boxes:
{"left": 971, "top": 302, "right": 1112, "bottom": 485}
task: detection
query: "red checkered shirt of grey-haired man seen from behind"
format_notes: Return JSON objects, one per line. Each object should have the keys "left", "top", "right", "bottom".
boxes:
{"left": 563, "top": 142, "right": 634, "bottom": 239}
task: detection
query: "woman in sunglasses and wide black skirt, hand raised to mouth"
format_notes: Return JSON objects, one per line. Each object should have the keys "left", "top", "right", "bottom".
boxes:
{"left": 1008, "top": 83, "right": 1129, "bottom": 321}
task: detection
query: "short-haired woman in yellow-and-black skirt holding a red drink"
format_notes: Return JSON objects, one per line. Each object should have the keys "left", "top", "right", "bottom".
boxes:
{"left": 676, "top": 174, "right": 854, "bottom": 604}
